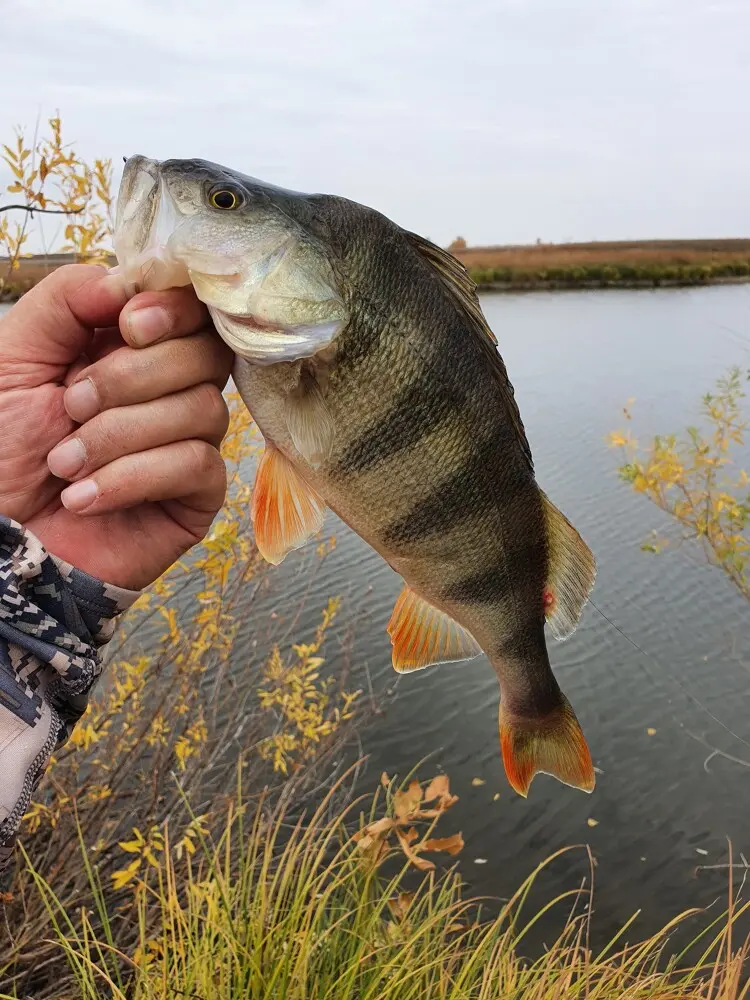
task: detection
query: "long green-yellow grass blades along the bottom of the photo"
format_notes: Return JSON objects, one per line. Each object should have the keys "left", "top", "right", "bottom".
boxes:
{"left": 14, "top": 779, "right": 748, "bottom": 1000}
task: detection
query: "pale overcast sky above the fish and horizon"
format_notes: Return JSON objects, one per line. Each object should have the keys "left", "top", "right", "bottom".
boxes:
{"left": 0, "top": 0, "right": 750, "bottom": 244}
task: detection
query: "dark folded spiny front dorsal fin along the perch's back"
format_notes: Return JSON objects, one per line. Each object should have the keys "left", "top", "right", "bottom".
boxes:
{"left": 404, "top": 231, "right": 534, "bottom": 471}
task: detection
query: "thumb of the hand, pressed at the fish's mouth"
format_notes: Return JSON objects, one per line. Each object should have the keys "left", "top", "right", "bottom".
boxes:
{"left": 0, "top": 264, "right": 127, "bottom": 368}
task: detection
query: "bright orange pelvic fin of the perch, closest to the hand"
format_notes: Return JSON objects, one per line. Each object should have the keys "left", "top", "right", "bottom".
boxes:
{"left": 252, "top": 444, "right": 326, "bottom": 566}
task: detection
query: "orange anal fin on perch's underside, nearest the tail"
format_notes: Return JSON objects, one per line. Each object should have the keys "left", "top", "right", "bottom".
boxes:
{"left": 388, "top": 586, "right": 482, "bottom": 674}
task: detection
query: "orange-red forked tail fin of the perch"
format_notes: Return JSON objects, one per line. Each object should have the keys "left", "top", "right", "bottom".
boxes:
{"left": 500, "top": 694, "right": 595, "bottom": 798}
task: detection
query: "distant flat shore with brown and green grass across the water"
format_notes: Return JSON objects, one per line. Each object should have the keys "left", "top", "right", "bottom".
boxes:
{"left": 0, "top": 239, "right": 750, "bottom": 301}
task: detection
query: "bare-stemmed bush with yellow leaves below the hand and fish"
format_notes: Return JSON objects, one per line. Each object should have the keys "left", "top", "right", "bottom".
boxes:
{"left": 0, "top": 394, "right": 364, "bottom": 998}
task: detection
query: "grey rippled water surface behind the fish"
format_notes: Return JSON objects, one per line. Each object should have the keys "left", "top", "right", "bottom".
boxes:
{"left": 0, "top": 286, "right": 750, "bottom": 940}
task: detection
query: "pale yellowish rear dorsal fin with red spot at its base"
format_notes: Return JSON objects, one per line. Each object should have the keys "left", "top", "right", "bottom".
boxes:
{"left": 542, "top": 493, "right": 596, "bottom": 639}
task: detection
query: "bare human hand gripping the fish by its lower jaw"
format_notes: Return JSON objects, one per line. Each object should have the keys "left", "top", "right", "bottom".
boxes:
{"left": 0, "top": 264, "right": 232, "bottom": 590}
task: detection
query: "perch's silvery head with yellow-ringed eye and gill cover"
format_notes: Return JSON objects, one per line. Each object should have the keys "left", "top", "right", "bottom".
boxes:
{"left": 114, "top": 156, "right": 348, "bottom": 365}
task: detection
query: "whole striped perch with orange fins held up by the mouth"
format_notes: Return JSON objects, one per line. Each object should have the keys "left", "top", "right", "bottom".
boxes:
{"left": 115, "top": 156, "right": 595, "bottom": 796}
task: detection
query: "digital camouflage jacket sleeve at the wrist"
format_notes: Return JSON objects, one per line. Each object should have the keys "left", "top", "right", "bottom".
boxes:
{"left": 0, "top": 515, "right": 138, "bottom": 872}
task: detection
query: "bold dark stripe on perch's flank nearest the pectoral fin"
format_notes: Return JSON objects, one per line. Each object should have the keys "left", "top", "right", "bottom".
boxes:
{"left": 337, "top": 379, "right": 461, "bottom": 474}
